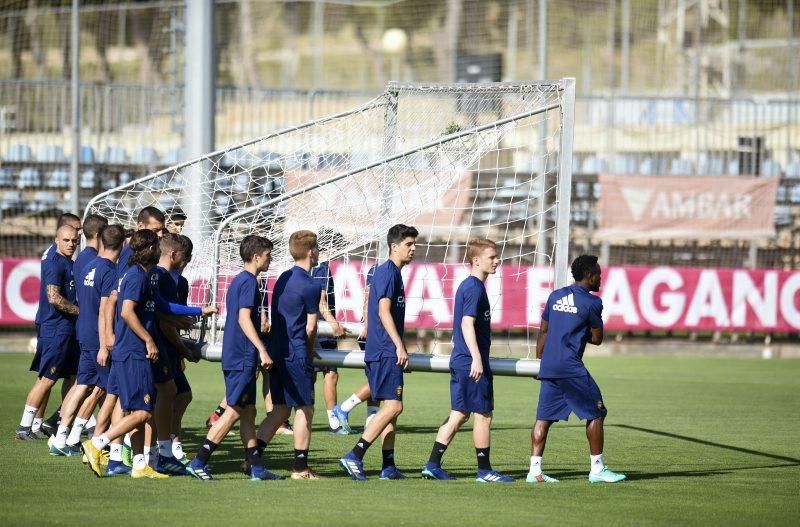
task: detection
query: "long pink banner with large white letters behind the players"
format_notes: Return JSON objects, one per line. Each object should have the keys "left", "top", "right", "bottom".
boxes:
{"left": 6, "top": 259, "right": 800, "bottom": 332}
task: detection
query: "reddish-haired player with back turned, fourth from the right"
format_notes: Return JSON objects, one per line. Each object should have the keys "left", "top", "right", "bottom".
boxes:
{"left": 253, "top": 231, "right": 320, "bottom": 479}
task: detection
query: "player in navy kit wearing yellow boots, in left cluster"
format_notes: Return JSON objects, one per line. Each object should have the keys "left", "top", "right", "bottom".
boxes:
{"left": 81, "top": 230, "right": 168, "bottom": 479}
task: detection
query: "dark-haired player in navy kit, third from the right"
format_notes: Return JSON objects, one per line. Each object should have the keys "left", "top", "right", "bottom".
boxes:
{"left": 339, "top": 224, "right": 419, "bottom": 480}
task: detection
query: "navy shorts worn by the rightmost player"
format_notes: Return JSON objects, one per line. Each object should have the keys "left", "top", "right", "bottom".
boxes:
{"left": 536, "top": 373, "right": 607, "bottom": 421}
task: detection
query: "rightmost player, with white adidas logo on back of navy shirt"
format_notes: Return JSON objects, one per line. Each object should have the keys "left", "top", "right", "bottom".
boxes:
{"left": 527, "top": 255, "right": 625, "bottom": 483}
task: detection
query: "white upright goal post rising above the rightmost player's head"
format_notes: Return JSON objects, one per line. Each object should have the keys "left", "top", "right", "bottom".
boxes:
{"left": 554, "top": 77, "right": 575, "bottom": 289}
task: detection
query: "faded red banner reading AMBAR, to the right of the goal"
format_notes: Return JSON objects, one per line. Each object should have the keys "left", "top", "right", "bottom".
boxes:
{"left": 596, "top": 174, "right": 778, "bottom": 241}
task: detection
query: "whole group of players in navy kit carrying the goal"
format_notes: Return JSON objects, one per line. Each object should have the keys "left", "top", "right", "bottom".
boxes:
{"left": 17, "top": 207, "right": 625, "bottom": 483}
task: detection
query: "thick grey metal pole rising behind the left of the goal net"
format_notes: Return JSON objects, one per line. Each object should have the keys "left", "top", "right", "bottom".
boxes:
{"left": 181, "top": 0, "right": 216, "bottom": 250}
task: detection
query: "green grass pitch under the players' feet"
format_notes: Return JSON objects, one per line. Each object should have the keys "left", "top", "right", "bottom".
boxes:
{"left": 0, "top": 354, "right": 800, "bottom": 525}
